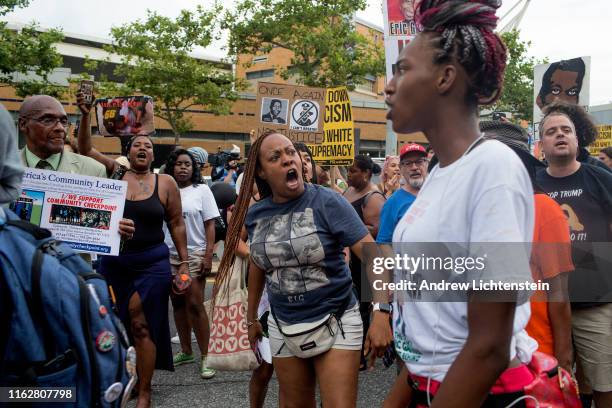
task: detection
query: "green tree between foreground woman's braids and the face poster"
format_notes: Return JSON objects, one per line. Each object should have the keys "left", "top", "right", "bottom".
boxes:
{"left": 493, "top": 30, "right": 544, "bottom": 122}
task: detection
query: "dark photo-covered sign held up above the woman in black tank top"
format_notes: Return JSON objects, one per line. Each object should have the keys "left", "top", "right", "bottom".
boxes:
{"left": 96, "top": 96, "right": 155, "bottom": 136}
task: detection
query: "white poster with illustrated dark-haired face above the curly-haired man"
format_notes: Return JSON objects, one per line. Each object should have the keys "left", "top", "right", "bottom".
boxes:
{"left": 533, "top": 57, "right": 591, "bottom": 140}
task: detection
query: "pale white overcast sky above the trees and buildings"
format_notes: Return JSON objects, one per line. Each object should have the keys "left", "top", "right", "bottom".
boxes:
{"left": 4, "top": 0, "right": 612, "bottom": 105}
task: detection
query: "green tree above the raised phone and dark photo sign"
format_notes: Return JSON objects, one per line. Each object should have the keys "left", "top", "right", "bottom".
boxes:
{"left": 107, "top": 6, "right": 242, "bottom": 144}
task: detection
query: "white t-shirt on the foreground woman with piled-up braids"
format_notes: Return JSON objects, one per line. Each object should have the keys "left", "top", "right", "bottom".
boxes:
{"left": 393, "top": 141, "right": 534, "bottom": 381}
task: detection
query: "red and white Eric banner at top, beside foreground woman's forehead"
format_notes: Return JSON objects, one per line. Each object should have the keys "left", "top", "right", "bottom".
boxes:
{"left": 383, "top": 0, "right": 422, "bottom": 82}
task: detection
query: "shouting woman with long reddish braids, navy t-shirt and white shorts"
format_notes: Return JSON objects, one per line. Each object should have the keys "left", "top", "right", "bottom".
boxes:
{"left": 214, "top": 132, "right": 392, "bottom": 407}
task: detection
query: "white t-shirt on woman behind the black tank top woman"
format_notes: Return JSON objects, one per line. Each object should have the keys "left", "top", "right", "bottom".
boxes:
{"left": 164, "top": 184, "right": 219, "bottom": 255}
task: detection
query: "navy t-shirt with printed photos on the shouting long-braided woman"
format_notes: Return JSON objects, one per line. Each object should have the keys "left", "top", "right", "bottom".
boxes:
{"left": 245, "top": 184, "right": 368, "bottom": 324}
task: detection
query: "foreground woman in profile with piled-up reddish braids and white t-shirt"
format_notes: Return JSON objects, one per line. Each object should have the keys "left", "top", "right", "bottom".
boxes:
{"left": 385, "top": 0, "right": 534, "bottom": 408}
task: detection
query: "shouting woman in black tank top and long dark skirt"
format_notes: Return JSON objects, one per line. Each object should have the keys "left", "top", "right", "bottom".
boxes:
{"left": 100, "top": 136, "right": 190, "bottom": 407}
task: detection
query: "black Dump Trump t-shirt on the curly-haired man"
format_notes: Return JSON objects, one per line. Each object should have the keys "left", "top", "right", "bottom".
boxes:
{"left": 536, "top": 163, "right": 612, "bottom": 307}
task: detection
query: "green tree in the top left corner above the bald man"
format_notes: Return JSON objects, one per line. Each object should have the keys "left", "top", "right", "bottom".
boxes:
{"left": 0, "top": 0, "right": 64, "bottom": 97}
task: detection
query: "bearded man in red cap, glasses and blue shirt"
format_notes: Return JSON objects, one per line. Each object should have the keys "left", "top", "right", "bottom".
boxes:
{"left": 376, "top": 143, "right": 429, "bottom": 244}
